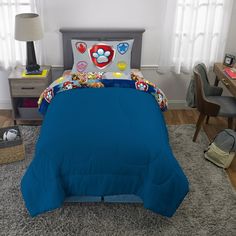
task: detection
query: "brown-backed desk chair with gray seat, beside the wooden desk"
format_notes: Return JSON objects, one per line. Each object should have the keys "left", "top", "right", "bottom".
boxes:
{"left": 193, "top": 64, "right": 236, "bottom": 142}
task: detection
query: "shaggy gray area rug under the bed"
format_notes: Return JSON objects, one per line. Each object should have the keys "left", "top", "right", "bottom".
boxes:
{"left": 0, "top": 125, "right": 236, "bottom": 236}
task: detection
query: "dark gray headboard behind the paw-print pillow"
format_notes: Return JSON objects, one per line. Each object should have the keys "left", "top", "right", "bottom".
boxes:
{"left": 60, "top": 28, "right": 145, "bottom": 70}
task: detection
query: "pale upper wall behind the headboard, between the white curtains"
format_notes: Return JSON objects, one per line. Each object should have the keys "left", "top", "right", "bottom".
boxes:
{"left": 40, "top": 0, "right": 164, "bottom": 66}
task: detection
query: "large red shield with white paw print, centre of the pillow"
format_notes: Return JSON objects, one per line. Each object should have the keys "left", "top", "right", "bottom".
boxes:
{"left": 89, "top": 44, "right": 115, "bottom": 69}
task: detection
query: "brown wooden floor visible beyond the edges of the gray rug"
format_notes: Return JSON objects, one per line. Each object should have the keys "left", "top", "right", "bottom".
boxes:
{"left": 0, "top": 109, "right": 236, "bottom": 188}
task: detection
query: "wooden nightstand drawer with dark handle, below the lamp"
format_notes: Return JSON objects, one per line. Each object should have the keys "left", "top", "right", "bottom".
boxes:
{"left": 10, "top": 80, "right": 47, "bottom": 97}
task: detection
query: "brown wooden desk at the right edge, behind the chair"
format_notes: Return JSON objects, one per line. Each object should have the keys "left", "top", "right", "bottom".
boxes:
{"left": 213, "top": 63, "right": 236, "bottom": 97}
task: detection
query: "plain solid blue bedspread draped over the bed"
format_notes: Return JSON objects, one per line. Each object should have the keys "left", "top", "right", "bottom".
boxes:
{"left": 21, "top": 88, "right": 188, "bottom": 217}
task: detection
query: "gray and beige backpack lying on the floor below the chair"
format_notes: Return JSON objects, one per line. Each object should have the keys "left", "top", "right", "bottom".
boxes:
{"left": 204, "top": 129, "right": 236, "bottom": 169}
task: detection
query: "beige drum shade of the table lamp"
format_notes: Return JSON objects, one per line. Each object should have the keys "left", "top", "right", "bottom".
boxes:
{"left": 15, "top": 13, "right": 43, "bottom": 41}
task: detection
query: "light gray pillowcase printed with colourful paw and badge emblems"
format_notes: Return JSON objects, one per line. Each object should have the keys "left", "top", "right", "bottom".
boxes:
{"left": 71, "top": 39, "right": 134, "bottom": 73}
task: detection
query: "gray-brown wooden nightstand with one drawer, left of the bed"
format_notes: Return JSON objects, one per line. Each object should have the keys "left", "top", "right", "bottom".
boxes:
{"left": 8, "top": 66, "right": 52, "bottom": 124}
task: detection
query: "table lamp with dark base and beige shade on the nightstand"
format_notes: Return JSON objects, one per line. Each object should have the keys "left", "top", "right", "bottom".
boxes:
{"left": 15, "top": 13, "right": 43, "bottom": 75}
